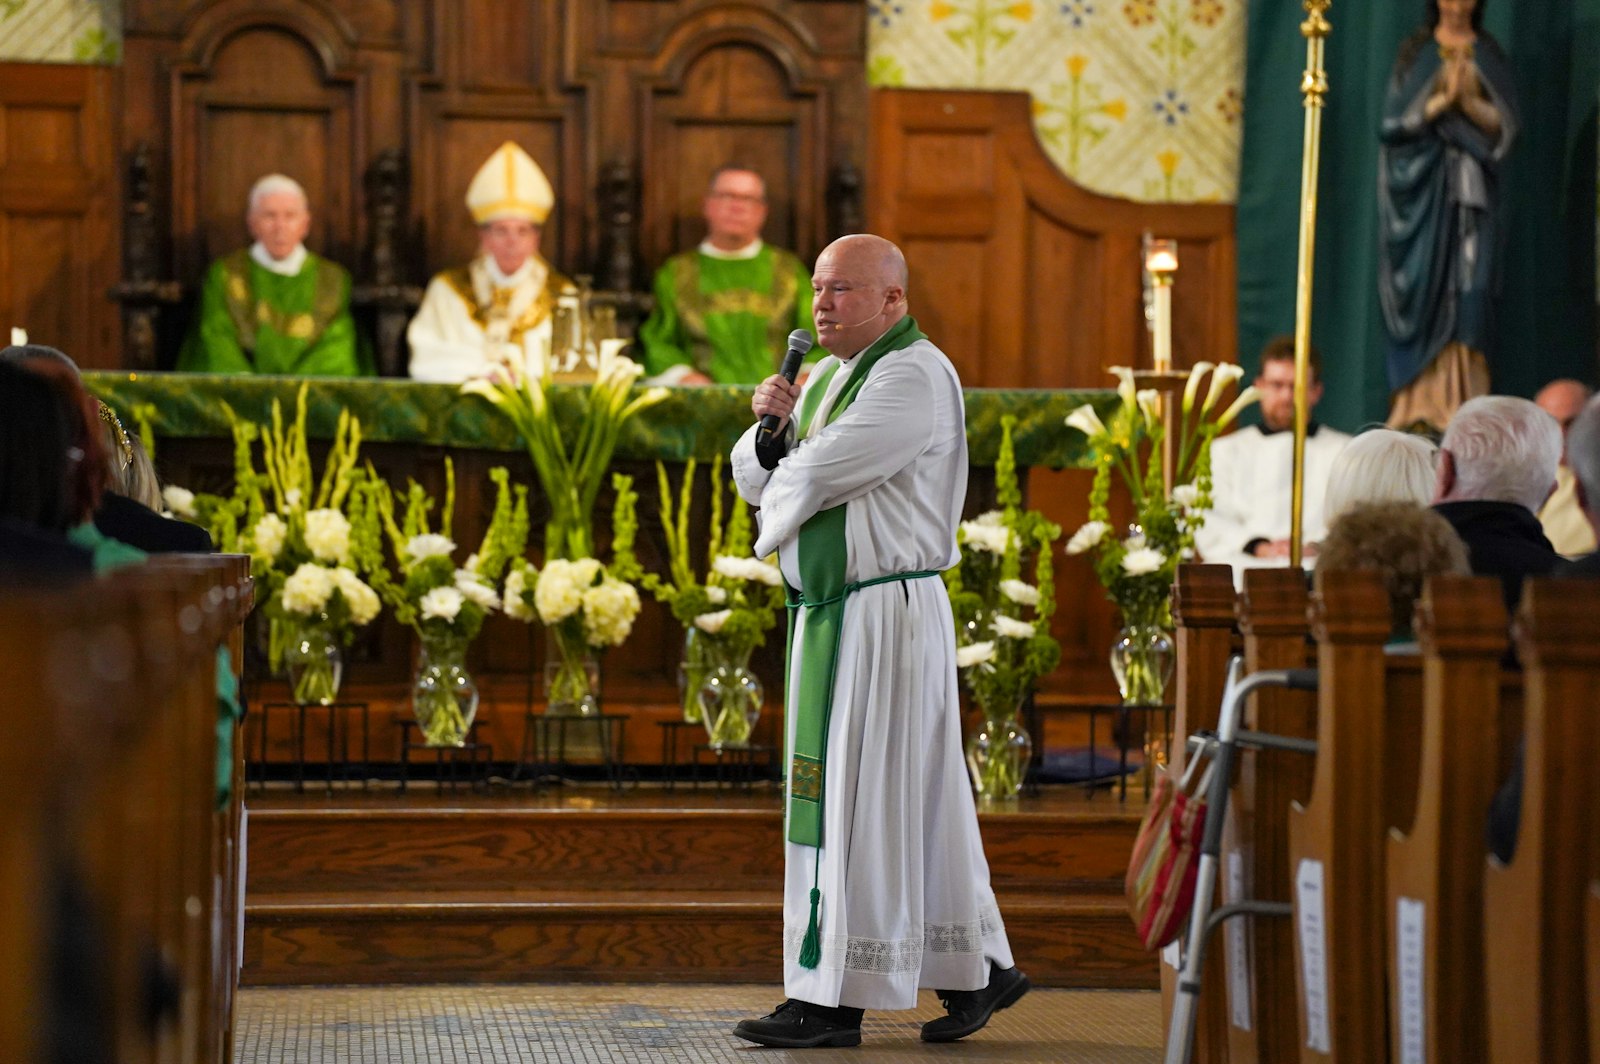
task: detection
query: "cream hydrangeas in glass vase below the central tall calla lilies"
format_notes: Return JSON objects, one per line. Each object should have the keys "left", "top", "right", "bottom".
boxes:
{"left": 504, "top": 474, "right": 638, "bottom": 717}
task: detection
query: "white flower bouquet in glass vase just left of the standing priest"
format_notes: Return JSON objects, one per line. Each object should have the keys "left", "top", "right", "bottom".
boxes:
{"left": 608, "top": 456, "right": 784, "bottom": 749}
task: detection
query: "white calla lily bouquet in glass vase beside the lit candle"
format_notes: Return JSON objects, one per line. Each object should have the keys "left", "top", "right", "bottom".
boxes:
{"left": 1067, "top": 362, "right": 1256, "bottom": 704}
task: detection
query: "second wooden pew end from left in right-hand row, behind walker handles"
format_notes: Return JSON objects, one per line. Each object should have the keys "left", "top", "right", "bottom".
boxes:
{"left": 1219, "top": 568, "right": 1317, "bottom": 1064}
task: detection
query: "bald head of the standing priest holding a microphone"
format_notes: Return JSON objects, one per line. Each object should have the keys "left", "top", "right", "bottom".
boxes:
{"left": 811, "top": 234, "right": 906, "bottom": 358}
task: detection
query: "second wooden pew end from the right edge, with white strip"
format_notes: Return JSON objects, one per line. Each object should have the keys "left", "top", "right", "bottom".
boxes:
{"left": 1384, "top": 576, "right": 1517, "bottom": 1064}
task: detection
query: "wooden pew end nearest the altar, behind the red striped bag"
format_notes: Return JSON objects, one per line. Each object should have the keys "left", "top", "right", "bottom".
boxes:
{"left": 1162, "top": 565, "right": 1237, "bottom": 1064}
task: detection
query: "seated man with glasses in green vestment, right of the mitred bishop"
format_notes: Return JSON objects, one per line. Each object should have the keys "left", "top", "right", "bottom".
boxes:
{"left": 638, "top": 163, "right": 811, "bottom": 384}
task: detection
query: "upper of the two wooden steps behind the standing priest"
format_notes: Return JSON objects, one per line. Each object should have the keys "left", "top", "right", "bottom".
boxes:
{"left": 248, "top": 795, "right": 1138, "bottom": 899}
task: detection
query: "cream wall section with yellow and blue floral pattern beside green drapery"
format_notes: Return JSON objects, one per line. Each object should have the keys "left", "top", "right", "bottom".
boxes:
{"left": 867, "top": 0, "right": 1245, "bottom": 203}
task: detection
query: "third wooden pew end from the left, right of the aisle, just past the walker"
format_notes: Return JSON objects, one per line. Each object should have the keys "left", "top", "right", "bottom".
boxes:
{"left": 1288, "top": 573, "right": 1390, "bottom": 1064}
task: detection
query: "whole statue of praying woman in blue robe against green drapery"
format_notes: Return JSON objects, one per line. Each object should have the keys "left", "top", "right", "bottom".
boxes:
{"left": 1378, "top": 0, "right": 1517, "bottom": 429}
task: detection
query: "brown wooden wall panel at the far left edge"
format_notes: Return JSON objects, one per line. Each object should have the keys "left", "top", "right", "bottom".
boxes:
{"left": 0, "top": 62, "right": 122, "bottom": 366}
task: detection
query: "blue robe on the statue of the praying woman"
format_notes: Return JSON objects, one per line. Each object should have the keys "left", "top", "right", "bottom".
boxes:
{"left": 1378, "top": 32, "right": 1517, "bottom": 392}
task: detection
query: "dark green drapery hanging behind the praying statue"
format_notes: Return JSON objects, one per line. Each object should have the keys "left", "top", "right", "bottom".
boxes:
{"left": 1238, "top": 0, "right": 1600, "bottom": 429}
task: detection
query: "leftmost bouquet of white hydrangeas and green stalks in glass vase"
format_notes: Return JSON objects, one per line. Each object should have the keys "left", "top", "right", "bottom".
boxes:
{"left": 183, "top": 386, "right": 381, "bottom": 704}
